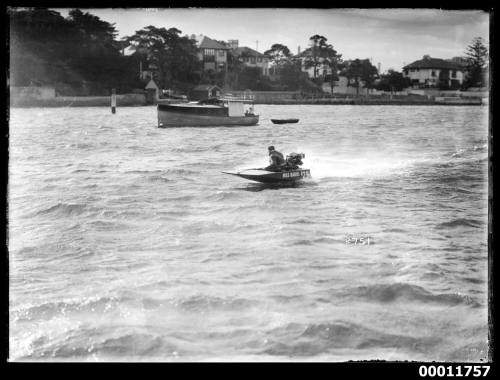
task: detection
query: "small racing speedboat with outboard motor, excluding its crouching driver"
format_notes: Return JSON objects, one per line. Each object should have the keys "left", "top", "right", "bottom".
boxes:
{"left": 222, "top": 153, "right": 311, "bottom": 183}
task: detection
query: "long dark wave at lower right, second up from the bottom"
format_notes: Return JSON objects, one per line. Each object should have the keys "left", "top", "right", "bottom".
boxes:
{"left": 344, "top": 283, "right": 481, "bottom": 307}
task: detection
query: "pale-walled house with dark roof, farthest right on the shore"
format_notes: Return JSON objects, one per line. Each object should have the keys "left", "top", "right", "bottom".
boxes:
{"left": 403, "top": 55, "right": 465, "bottom": 88}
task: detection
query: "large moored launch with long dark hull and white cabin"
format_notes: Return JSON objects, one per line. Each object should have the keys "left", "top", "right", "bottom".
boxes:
{"left": 158, "top": 95, "right": 259, "bottom": 128}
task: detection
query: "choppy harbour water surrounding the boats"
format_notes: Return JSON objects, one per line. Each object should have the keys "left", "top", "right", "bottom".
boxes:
{"left": 8, "top": 105, "right": 488, "bottom": 361}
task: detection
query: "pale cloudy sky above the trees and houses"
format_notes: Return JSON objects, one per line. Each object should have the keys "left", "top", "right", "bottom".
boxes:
{"left": 55, "top": 8, "right": 489, "bottom": 72}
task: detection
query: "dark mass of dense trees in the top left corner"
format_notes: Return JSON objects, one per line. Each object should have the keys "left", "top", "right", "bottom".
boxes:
{"left": 9, "top": 8, "right": 142, "bottom": 95}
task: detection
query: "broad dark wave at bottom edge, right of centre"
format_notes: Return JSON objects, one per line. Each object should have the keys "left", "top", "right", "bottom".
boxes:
{"left": 262, "top": 320, "right": 441, "bottom": 356}
